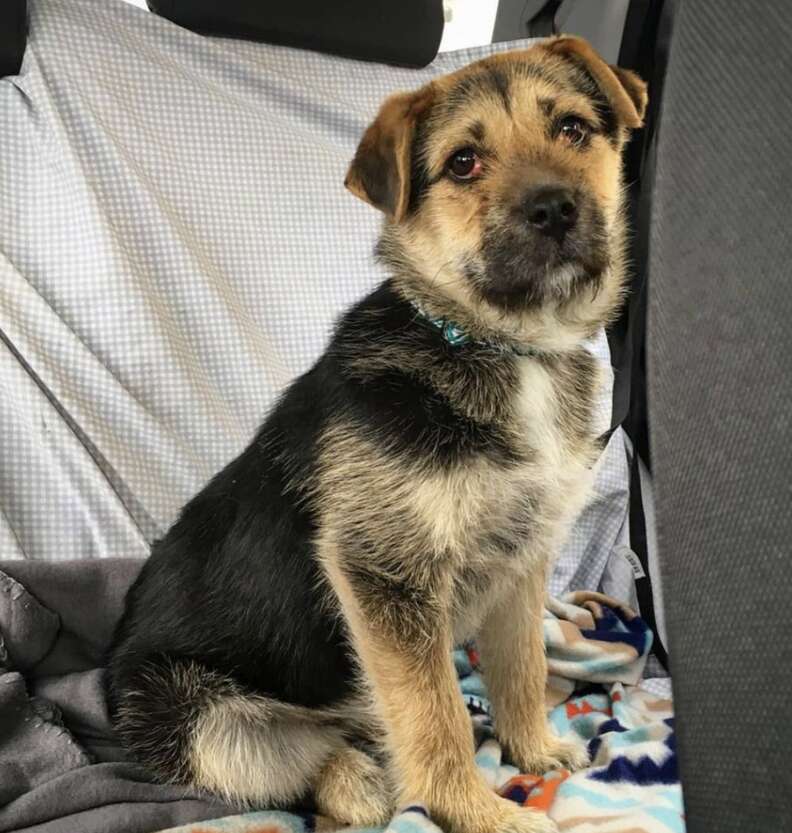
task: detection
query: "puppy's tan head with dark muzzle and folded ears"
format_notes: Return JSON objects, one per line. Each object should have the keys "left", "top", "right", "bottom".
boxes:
{"left": 346, "top": 37, "right": 647, "bottom": 349}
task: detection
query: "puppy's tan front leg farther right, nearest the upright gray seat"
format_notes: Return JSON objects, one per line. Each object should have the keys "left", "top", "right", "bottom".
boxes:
{"left": 478, "top": 569, "right": 588, "bottom": 775}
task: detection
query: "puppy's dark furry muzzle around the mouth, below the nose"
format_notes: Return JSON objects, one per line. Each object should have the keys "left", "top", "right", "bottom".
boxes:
{"left": 464, "top": 208, "right": 610, "bottom": 310}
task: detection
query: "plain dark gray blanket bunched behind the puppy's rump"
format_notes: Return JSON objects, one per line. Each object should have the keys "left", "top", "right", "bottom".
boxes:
{"left": 0, "top": 559, "right": 238, "bottom": 833}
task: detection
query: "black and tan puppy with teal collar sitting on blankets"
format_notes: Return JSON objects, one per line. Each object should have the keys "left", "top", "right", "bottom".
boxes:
{"left": 106, "top": 36, "right": 647, "bottom": 833}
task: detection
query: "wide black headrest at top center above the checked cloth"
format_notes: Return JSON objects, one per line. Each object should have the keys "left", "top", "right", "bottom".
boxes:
{"left": 148, "top": 0, "right": 443, "bottom": 67}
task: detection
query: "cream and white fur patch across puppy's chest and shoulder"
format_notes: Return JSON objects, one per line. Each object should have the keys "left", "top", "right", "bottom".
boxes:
{"left": 312, "top": 358, "right": 594, "bottom": 638}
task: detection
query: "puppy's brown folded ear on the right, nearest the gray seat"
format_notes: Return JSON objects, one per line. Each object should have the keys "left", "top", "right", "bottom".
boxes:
{"left": 547, "top": 35, "right": 649, "bottom": 128}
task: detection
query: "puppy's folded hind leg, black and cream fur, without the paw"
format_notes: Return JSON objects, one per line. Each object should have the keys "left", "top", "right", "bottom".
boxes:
{"left": 109, "top": 654, "right": 345, "bottom": 807}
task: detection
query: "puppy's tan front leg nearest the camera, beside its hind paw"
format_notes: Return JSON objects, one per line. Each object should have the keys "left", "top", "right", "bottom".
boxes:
{"left": 325, "top": 557, "right": 556, "bottom": 833}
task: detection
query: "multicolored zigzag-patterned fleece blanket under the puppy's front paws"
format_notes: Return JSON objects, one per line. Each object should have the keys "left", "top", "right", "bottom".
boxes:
{"left": 159, "top": 592, "right": 685, "bottom": 833}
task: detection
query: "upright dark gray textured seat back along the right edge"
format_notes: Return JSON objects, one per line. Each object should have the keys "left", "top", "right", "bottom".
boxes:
{"left": 648, "top": 0, "right": 792, "bottom": 833}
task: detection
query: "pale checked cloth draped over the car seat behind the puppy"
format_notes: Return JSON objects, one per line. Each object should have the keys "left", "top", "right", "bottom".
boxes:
{"left": 0, "top": 0, "right": 634, "bottom": 604}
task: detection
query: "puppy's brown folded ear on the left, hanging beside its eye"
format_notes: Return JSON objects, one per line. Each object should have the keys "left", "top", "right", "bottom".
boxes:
{"left": 344, "top": 85, "right": 432, "bottom": 222}
